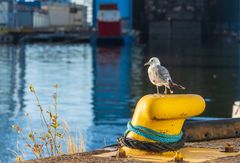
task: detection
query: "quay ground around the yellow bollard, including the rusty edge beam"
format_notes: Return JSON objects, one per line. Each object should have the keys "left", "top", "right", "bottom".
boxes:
{"left": 23, "top": 118, "right": 240, "bottom": 163}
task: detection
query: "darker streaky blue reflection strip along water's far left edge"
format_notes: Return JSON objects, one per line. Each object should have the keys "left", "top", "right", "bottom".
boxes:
{"left": 0, "top": 45, "right": 25, "bottom": 160}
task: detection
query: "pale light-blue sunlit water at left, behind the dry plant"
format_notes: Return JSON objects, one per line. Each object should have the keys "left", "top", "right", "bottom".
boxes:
{"left": 0, "top": 44, "right": 94, "bottom": 162}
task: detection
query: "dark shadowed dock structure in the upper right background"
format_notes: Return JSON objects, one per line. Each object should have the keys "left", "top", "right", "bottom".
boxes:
{"left": 133, "top": 0, "right": 240, "bottom": 44}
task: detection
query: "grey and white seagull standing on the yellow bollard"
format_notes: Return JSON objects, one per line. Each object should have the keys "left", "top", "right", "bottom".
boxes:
{"left": 144, "top": 57, "right": 185, "bottom": 94}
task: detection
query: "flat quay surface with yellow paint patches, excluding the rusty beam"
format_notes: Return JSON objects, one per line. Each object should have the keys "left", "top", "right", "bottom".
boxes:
{"left": 25, "top": 138, "right": 240, "bottom": 163}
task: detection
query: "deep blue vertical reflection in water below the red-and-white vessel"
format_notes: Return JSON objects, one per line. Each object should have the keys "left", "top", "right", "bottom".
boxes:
{"left": 88, "top": 46, "right": 131, "bottom": 148}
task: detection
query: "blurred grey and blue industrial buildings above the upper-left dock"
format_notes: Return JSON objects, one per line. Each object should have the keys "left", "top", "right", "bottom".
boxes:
{"left": 0, "top": 0, "right": 87, "bottom": 30}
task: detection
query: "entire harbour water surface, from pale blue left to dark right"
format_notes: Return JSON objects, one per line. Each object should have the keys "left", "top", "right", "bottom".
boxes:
{"left": 0, "top": 43, "right": 240, "bottom": 162}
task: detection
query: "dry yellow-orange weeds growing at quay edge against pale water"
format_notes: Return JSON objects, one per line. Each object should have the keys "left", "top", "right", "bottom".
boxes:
{"left": 12, "top": 84, "right": 84, "bottom": 160}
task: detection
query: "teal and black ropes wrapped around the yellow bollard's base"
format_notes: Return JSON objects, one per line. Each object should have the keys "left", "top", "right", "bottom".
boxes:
{"left": 118, "top": 122, "right": 185, "bottom": 152}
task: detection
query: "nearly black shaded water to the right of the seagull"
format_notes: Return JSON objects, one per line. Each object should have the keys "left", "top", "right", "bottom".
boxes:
{"left": 149, "top": 40, "right": 240, "bottom": 117}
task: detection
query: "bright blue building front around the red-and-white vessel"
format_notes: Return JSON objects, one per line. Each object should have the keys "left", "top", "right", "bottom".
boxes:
{"left": 93, "top": 0, "right": 132, "bottom": 30}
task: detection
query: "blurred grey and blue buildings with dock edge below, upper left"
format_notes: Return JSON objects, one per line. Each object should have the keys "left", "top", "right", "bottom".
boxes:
{"left": 0, "top": 0, "right": 92, "bottom": 43}
